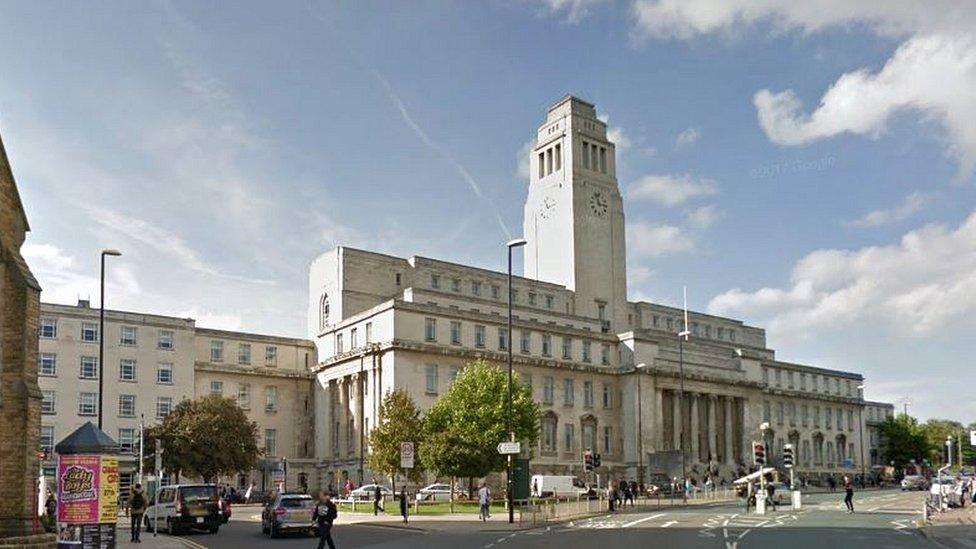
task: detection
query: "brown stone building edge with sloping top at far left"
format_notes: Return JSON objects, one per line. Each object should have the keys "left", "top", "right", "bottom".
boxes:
{"left": 0, "top": 128, "right": 53, "bottom": 547}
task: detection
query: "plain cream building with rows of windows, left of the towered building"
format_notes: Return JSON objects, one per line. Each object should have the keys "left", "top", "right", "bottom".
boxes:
{"left": 35, "top": 301, "right": 315, "bottom": 491}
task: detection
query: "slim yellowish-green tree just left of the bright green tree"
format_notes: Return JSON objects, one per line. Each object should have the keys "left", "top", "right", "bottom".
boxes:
{"left": 369, "top": 389, "right": 423, "bottom": 482}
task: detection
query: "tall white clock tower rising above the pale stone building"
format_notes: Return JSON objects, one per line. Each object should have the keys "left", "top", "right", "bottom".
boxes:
{"left": 523, "top": 96, "right": 628, "bottom": 332}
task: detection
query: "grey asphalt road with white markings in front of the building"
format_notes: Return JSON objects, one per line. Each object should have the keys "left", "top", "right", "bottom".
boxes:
{"left": 168, "top": 491, "right": 934, "bottom": 549}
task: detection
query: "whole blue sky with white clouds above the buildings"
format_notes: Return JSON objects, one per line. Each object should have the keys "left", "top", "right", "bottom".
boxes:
{"left": 0, "top": 0, "right": 976, "bottom": 423}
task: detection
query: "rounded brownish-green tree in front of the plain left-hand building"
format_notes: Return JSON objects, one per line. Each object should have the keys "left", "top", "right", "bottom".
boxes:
{"left": 145, "top": 395, "right": 261, "bottom": 482}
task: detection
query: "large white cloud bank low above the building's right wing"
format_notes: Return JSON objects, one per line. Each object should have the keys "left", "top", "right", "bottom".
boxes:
{"left": 708, "top": 212, "right": 976, "bottom": 338}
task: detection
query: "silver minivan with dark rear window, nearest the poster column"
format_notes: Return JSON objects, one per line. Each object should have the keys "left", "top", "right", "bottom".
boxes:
{"left": 143, "top": 484, "right": 224, "bottom": 535}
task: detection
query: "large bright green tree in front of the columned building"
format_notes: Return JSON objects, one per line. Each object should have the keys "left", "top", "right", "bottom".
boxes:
{"left": 421, "top": 360, "right": 539, "bottom": 477}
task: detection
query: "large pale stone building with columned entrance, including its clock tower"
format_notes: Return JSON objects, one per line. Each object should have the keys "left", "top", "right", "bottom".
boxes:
{"left": 308, "top": 97, "right": 892, "bottom": 484}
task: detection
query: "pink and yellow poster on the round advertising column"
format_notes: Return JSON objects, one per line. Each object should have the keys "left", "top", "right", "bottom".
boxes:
{"left": 58, "top": 455, "right": 101, "bottom": 524}
